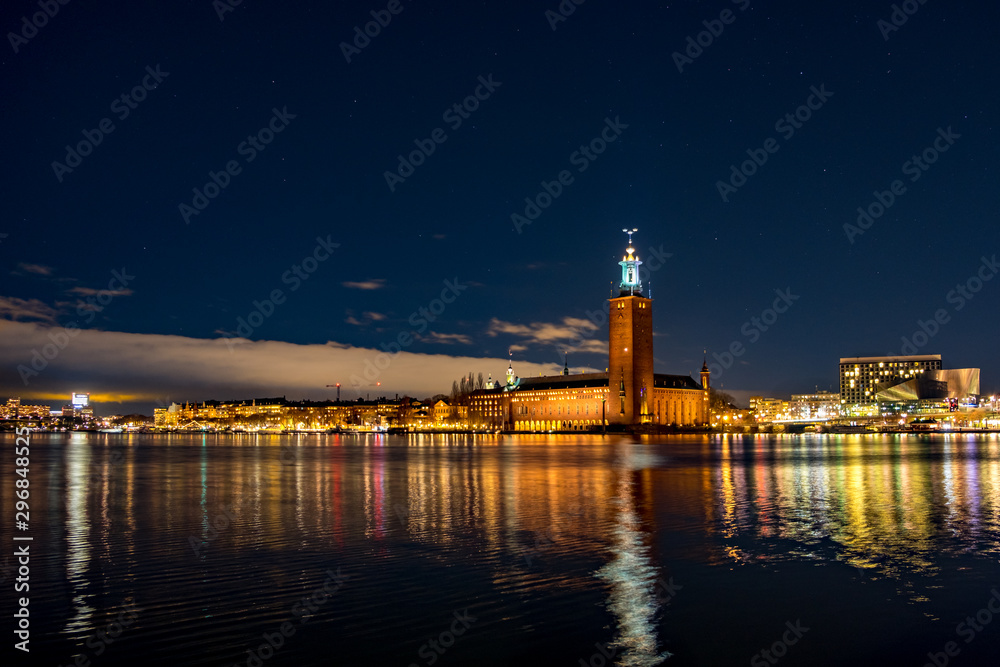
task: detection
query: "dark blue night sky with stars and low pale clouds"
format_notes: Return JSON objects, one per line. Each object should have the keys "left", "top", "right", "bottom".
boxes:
{"left": 0, "top": 0, "right": 1000, "bottom": 414}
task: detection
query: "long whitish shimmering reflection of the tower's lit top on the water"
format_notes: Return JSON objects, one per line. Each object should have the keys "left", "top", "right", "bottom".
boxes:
{"left": 597, "top": 443, "right": 670, "bottom": 667}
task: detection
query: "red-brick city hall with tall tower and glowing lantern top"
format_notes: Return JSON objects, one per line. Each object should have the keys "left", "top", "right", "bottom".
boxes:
{"left": 469, "top": 235, "right": 709, "bottom": 431}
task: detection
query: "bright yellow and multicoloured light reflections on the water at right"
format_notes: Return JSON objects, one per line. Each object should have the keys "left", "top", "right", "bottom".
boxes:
{"left": 706, "top": 434, "right": 1000, "bottom": 578}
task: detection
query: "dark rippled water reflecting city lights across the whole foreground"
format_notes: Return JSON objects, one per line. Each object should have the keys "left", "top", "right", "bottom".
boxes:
{"left": 0, "top": 434, "right": 1000, "bottom": 667}
